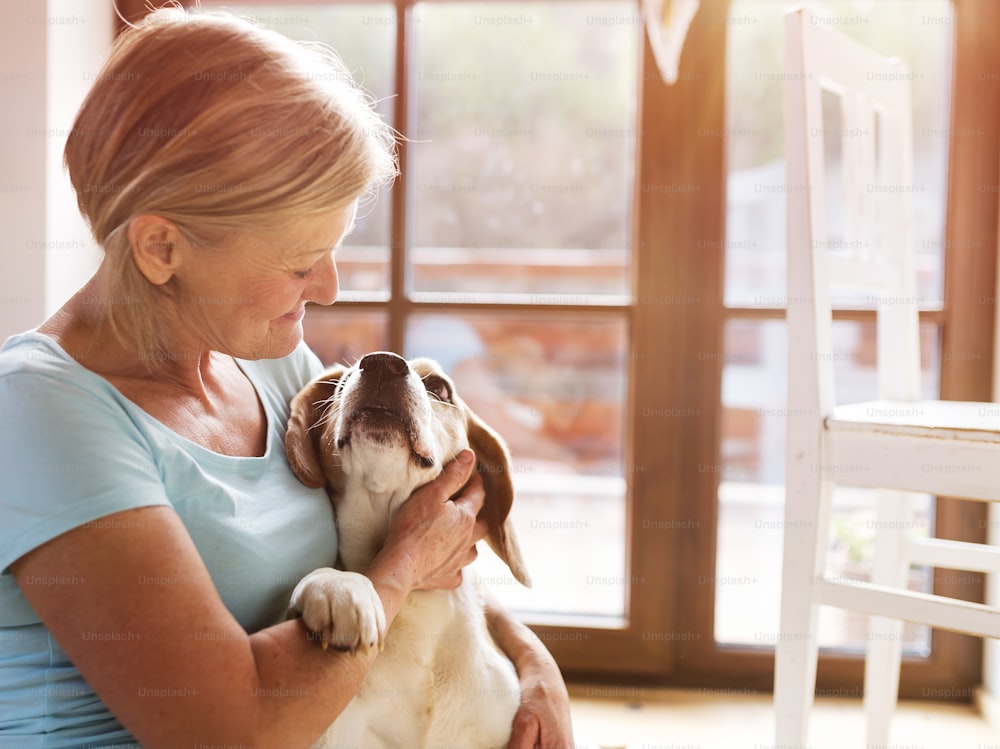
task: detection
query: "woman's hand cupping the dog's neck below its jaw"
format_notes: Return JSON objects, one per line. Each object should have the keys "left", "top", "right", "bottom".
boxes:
{"left": 372, "top": 450, "right": 486, "bottom": 590}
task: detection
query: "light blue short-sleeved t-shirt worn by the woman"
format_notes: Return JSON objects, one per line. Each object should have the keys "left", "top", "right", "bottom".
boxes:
{"left": 0, "top": 332, "right": 337, "bottom": 749}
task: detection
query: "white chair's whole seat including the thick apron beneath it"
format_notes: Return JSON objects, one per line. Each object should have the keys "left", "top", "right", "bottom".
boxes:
{"left": 824, "top": 401, "right": 1000, "bottom": 502}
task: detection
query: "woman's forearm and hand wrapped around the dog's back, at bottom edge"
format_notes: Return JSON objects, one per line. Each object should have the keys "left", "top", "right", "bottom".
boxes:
{"left": 485, "top": 591, "right": 574, "bottom": 749}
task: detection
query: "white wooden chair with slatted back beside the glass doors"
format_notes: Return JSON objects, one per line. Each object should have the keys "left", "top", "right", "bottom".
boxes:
{"left": 774, "top": 10, "right": 1000, "bottom": 746}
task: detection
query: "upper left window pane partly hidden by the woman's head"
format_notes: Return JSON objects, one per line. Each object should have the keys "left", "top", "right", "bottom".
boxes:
{"left": 217, "top": 3, "right": 396, "bottom": 299}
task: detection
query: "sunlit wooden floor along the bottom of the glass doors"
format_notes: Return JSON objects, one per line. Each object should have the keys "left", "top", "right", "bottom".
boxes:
{"left": 570, "top": 685, "right": 1000, "bottom": 749}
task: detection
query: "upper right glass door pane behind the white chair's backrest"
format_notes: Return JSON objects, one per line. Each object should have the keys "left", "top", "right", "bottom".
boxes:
{"left": 724, "top": 0, "right": 948, "bottom": 307}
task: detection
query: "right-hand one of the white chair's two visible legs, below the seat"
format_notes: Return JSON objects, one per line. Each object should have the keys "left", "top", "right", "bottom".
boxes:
{"left": 865, "top": 491, "right": 914, "bottom": 746}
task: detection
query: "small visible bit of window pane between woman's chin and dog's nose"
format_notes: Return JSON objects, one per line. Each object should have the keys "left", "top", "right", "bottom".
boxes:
{"left": 302, "top": 307, "right": 389, "bottom": 366}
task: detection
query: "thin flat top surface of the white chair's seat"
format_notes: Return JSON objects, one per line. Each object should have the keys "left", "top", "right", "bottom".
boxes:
{"left": 826, "top": 400, "right": 1000, "bottom": 442}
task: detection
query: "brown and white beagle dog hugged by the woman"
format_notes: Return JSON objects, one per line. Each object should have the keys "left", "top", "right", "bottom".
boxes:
{"left": 286, "top": 352, "right": 530, "bottom": 749}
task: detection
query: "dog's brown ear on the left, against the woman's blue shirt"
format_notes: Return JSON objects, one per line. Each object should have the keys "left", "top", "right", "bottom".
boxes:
{"left": 285, "top": 364, "right": 347, "bottom": 489}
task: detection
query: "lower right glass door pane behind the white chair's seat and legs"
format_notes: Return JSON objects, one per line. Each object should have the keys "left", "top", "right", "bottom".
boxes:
{"left": 720, "top": 320, "right": 940, "bottom": 654}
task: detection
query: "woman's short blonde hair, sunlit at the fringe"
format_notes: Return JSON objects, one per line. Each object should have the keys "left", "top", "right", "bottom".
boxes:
{"left": 64, "top": 7, "right": 397, "bottom": 359}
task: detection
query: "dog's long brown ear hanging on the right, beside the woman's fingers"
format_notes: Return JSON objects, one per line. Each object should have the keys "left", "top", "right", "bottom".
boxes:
{"left": 467, "top": 408, "right": 531, "bottom": 588}
